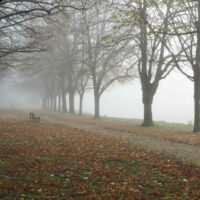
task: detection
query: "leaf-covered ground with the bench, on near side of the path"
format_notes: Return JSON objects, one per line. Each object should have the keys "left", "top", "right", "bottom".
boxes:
{"left": 0, "top": 111, "right": 200, "bottom": 200}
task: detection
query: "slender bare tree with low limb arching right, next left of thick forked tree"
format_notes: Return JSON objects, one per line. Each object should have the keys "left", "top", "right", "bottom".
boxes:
{"left": 83, "top": 1, "right": 131, "bottom": 118}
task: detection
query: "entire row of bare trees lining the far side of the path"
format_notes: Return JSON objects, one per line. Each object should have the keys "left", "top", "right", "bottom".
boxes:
{"left": 1, "top": 0, "right": 200, "bottom": 132}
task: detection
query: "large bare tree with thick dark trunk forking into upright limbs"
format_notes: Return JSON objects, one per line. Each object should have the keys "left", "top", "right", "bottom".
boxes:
{"left": 111, "top": 0, "right": 177, "bottom": 126}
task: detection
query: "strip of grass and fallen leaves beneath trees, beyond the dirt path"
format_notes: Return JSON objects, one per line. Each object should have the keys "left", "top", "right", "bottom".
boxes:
{"left": 41, "top": 112, "right": 200, "bottom": 145}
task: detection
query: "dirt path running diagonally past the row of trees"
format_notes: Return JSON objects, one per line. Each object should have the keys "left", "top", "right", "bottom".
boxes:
{"left": 41, "top": 114, "right": 200, "bottom": 166}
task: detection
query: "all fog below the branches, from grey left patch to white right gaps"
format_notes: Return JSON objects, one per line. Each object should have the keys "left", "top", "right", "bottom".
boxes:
{"left": 0, "top": 71, "right": 193, "bottom": 123}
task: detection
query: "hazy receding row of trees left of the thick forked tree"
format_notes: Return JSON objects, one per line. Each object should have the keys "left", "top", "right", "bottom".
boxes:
{"left": 22, "top": 3, "right": 131, "bottom": 118}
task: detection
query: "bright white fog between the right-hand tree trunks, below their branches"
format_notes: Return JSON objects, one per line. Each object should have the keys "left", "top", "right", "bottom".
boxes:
{"left": 81, "top": 72, "right": 193, "bottom": 123}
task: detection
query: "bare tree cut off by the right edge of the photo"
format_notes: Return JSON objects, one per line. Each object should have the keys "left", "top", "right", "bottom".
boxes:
{"left": 164, "top": 0, "right": 200, "bottom": 132}
